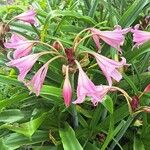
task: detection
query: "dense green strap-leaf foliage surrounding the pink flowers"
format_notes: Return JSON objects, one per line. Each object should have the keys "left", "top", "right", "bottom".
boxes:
{"left": 0, "top": 0, "right": 150, "bottom": 150}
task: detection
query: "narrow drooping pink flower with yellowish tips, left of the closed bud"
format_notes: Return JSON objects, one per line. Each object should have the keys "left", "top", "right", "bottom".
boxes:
{"left": 25, "top": 63, "right": 49, "bottom": 96}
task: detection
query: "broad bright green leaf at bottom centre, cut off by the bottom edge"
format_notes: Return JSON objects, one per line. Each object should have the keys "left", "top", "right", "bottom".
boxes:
{"left": 59, "top": 124, "right": 83, "bottom": 150}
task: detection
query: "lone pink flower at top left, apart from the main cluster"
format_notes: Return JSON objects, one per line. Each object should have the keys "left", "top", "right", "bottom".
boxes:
{"left": 14, "top": 8, "right": 37, "bottom": 25}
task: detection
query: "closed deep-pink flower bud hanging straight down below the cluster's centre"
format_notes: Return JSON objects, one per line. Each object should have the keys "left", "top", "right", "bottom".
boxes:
{"left": 63, "top": 66, "right": 72, "bottom": 107}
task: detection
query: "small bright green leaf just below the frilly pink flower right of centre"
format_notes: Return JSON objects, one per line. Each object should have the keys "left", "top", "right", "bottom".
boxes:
{"left": 102, "top": 95, "right": 113, "bottom": 114}
